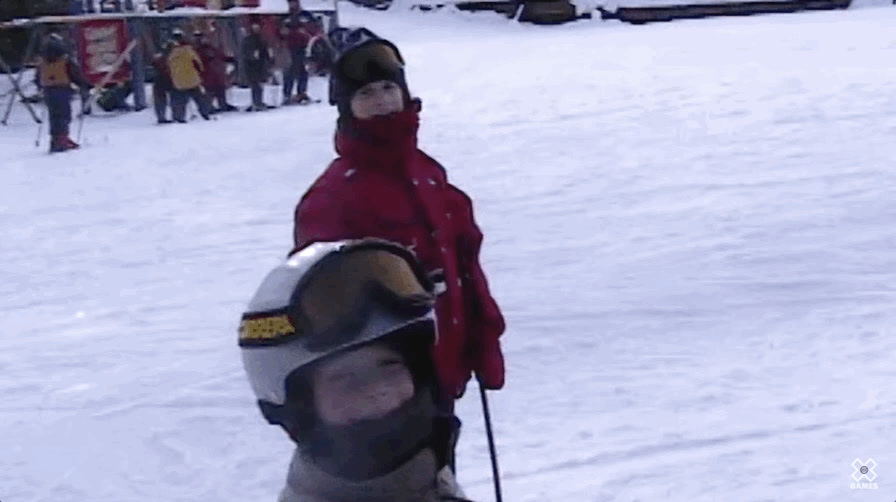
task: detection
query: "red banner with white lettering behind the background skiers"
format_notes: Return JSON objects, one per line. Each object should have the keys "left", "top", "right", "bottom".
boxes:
{"left": 77, "top": 20, "right": 131, "bottom": 85}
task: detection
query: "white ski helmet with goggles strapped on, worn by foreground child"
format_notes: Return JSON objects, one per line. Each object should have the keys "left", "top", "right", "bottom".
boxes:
{"left": 239, "top": 238, "right": 436, "bottom": 427}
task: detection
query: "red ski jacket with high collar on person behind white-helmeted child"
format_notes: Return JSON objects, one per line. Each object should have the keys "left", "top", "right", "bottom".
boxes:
{"left": 294, "top": 102, "right": 504, "bottom": 398}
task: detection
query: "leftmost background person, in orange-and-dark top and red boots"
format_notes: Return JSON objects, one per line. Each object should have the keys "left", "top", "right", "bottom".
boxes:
{"left": 35, "top": 33, "right": 90, "bottom": 152}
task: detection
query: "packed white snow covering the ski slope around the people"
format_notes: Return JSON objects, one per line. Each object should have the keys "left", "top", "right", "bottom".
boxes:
{"left": 0, "top": 3, "right": 896, "bottom": 502}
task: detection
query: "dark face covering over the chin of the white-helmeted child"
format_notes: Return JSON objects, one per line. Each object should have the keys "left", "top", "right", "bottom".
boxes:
{"left": 302, "top": 389, "right": 436, "bottom": 481}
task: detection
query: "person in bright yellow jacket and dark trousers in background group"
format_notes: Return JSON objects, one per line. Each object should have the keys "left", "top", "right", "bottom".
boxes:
{"left": 168, "top": 29, "right": 210, "bottom": 123}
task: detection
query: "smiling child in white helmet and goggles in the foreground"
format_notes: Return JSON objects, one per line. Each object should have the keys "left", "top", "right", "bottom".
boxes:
{"left": 239, "top": 239, "right": 470, "bottom": 502}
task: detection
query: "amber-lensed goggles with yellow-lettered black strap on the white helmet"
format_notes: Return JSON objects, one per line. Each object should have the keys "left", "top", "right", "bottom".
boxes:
{"left": 239, "top": 240, "right": 435, "bottom": 353}
